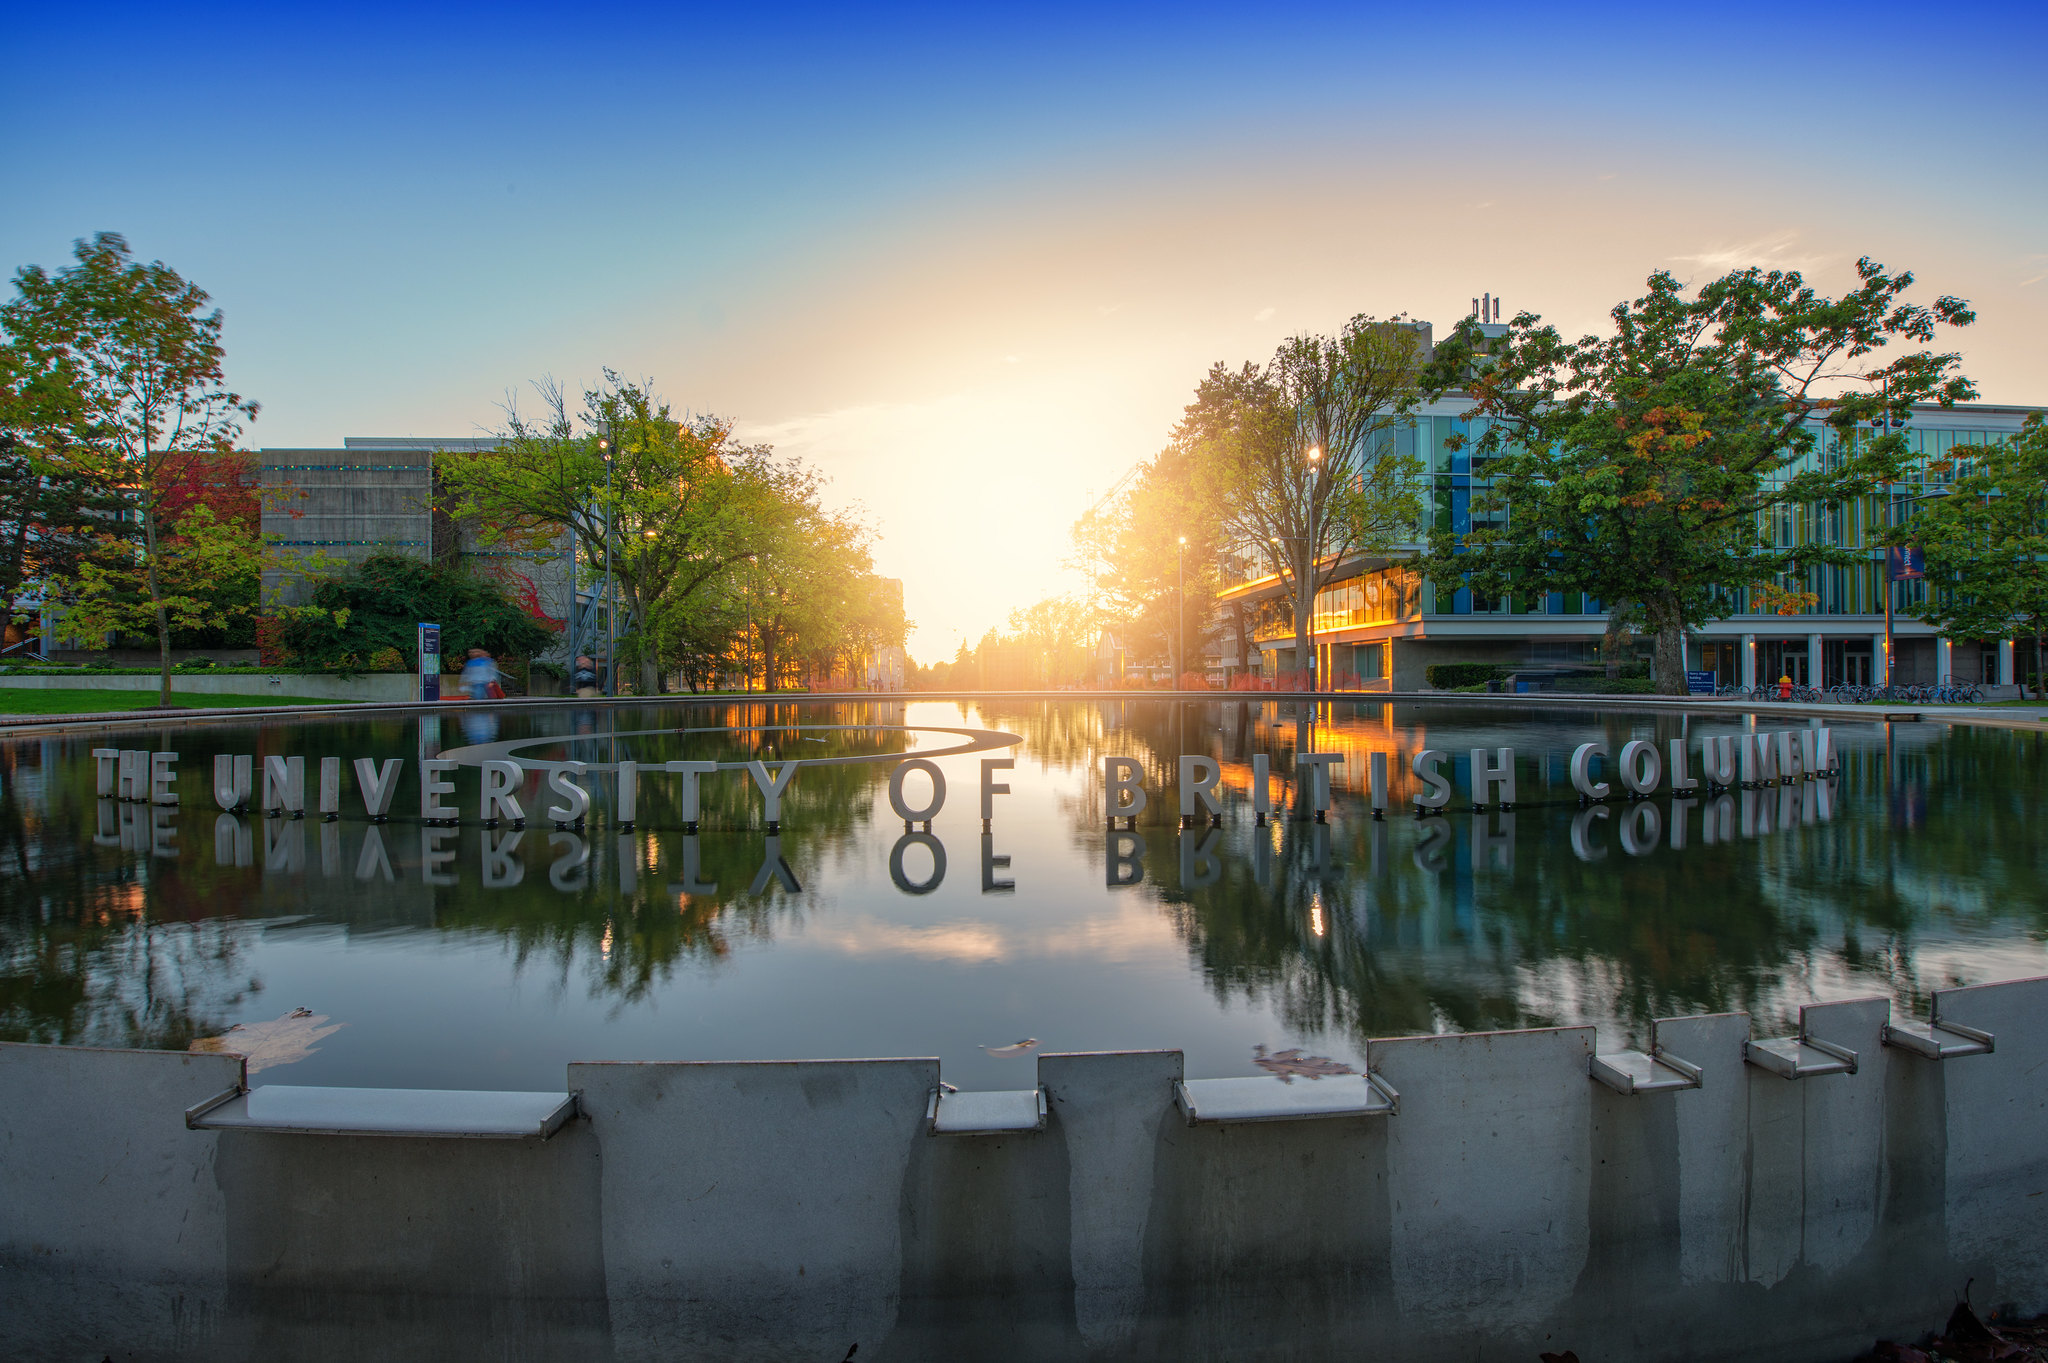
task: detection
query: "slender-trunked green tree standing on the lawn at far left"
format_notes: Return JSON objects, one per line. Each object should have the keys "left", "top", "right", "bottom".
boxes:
{"left": 0, "top": 231, "right": 256, "bottom": 706}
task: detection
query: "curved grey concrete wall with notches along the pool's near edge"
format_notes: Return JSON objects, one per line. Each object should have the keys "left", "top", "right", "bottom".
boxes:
{"left": 0, "top": 980, "right": 2048, "bottom": 1363}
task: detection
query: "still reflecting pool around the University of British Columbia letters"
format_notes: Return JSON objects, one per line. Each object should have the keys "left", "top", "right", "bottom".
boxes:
{"left": 0, "top": 698, "right": 2048, "bottom": 1089}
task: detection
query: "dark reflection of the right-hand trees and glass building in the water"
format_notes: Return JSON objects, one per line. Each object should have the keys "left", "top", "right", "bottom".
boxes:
{"left": 1064, "top": 700, "right": 2048, "bottom": 1038}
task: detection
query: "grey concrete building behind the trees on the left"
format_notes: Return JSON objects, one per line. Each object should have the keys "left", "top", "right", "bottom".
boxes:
{"left": 260, "top": 436, "right": 569, "bottom": 647}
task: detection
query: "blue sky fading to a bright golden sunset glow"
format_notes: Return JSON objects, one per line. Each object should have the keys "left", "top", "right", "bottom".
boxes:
{"left": 0, "top": 4, "right": 2048, "bottom": 661}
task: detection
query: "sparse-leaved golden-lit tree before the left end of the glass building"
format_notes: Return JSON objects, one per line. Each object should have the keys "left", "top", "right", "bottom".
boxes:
{"left": 1174, "top": 315, "right": 1425, "bottom": 686}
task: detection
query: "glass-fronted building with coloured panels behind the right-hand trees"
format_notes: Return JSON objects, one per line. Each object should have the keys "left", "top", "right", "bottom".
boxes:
{"left": 1223, "top": 323, "right": 2036, "bottom": 692}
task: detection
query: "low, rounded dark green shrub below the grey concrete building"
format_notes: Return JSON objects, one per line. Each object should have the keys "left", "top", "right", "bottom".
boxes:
{"left": 268, "top": 555, "right": 555, "bottom": 671}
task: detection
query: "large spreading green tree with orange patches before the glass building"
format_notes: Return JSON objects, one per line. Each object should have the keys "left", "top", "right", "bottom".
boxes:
{"left": 1425, "top": 260, "right": 1974, "bottom": 696}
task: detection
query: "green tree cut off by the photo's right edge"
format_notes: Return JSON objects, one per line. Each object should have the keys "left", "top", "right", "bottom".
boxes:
{"left": 1888, "top": 411, "right": 2048, "bottom": 686}
